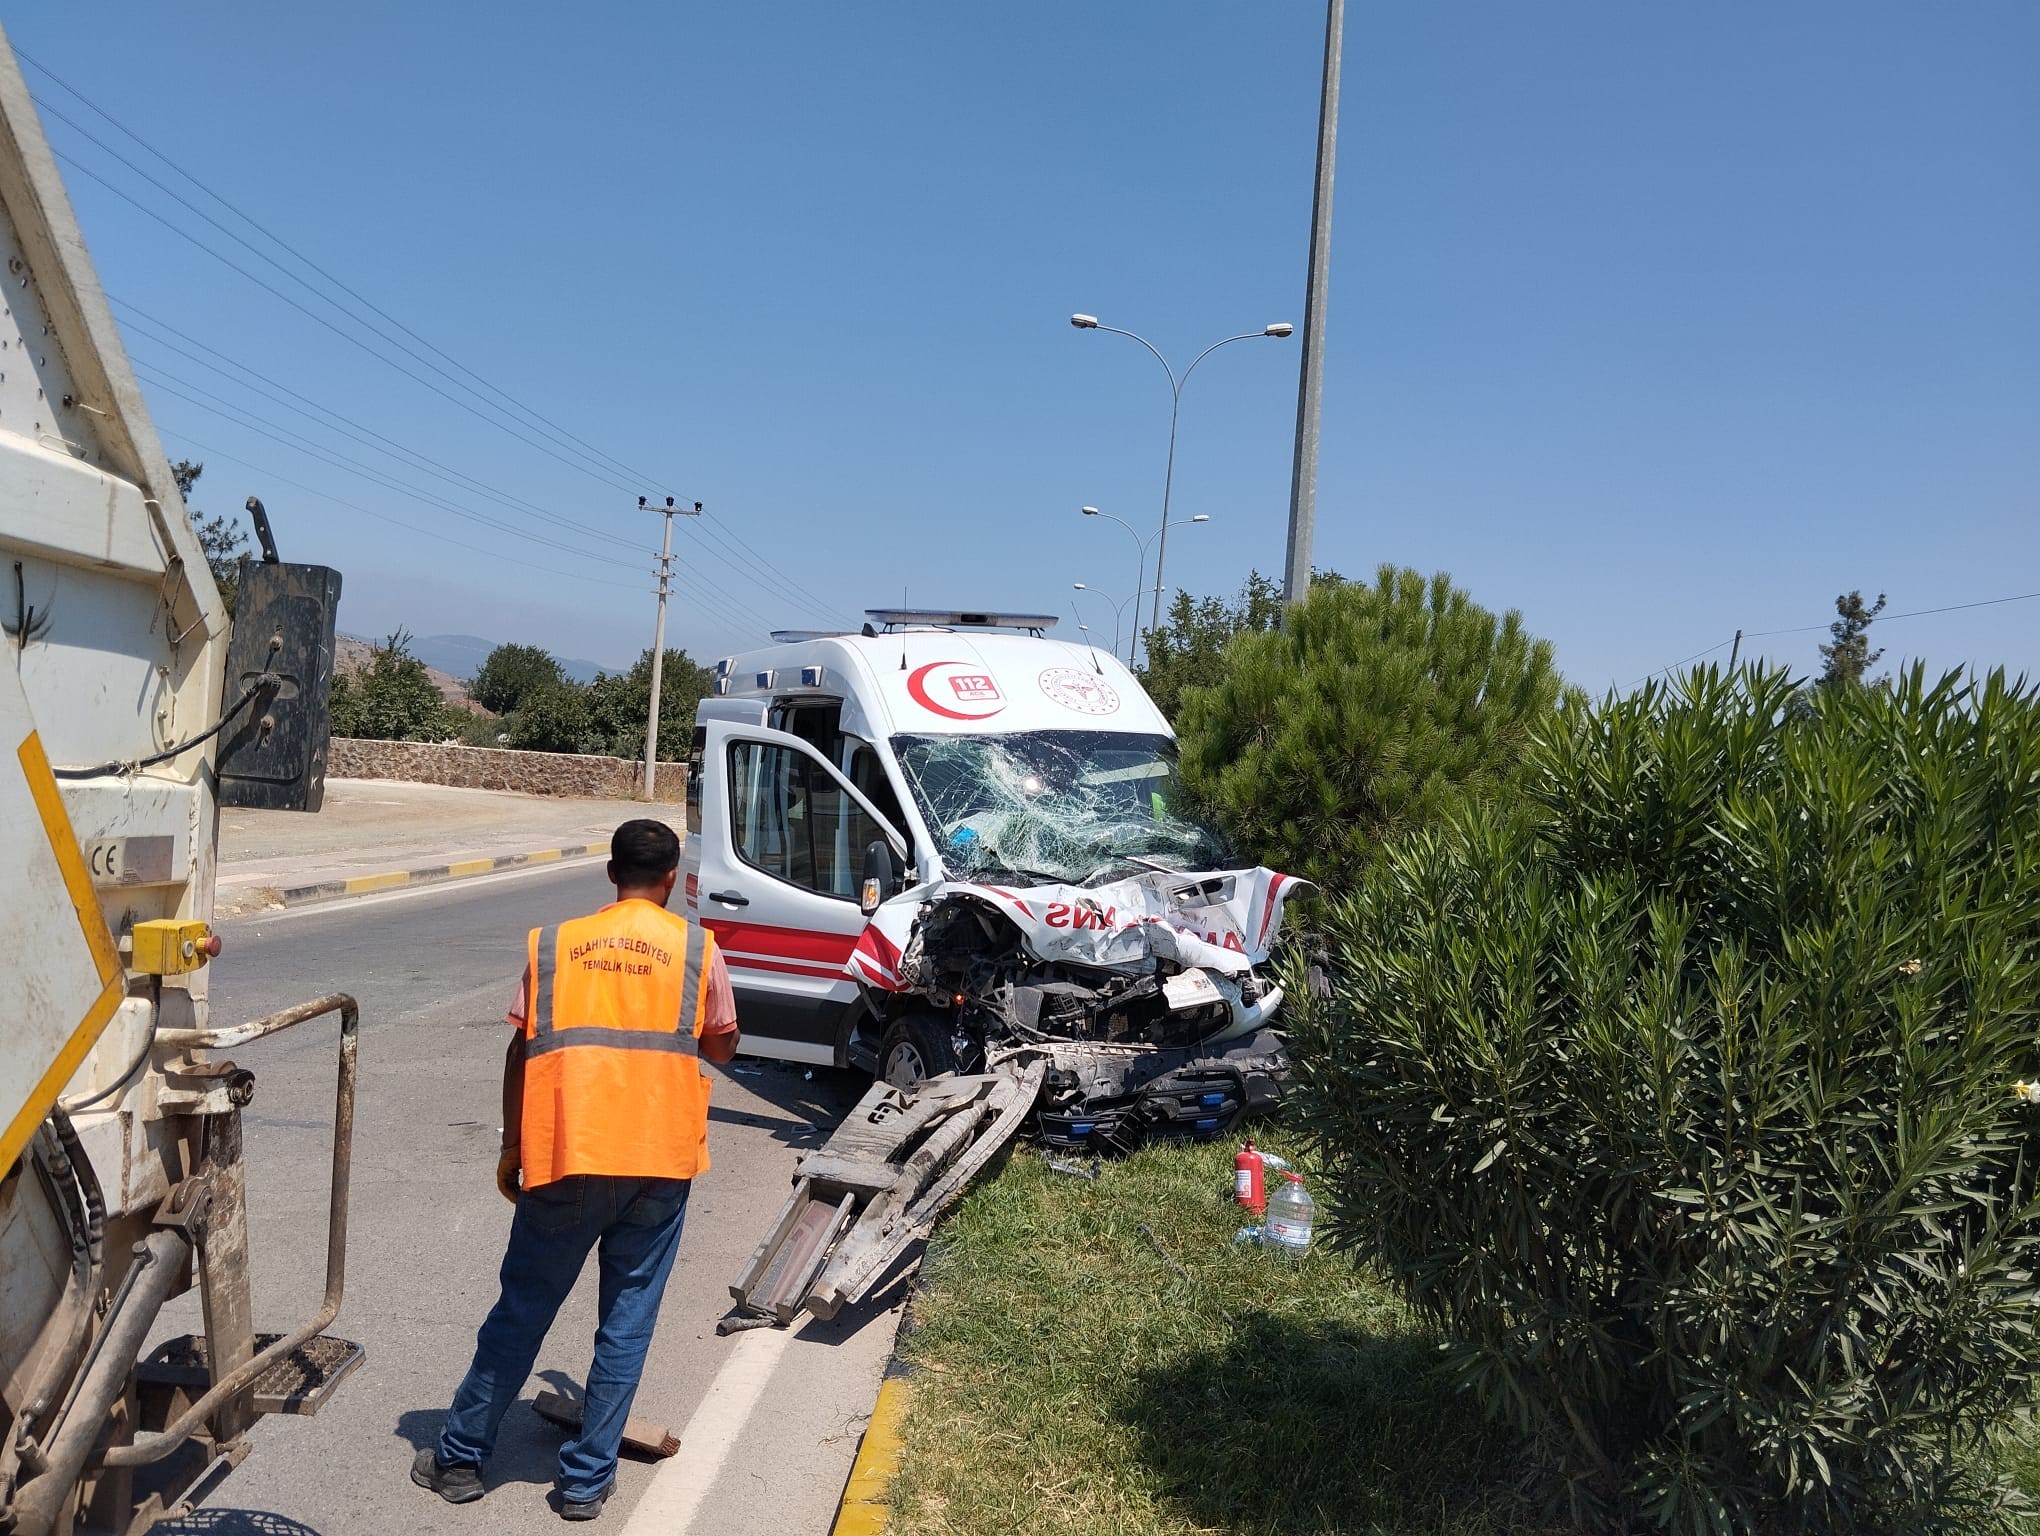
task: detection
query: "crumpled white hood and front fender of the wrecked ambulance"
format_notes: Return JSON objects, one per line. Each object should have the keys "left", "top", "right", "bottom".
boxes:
{"left": 845, "top": 869, "right": 1310, "bottom": 991}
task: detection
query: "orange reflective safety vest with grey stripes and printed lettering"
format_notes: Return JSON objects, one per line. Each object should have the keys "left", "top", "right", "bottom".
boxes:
{"left": 520, "top": 898, "right": 716, "bottom": 1189}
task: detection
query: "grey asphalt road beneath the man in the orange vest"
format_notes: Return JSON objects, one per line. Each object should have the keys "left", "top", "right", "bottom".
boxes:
{"left": 157, "top": 865, "right": 904, "bottom": 1536}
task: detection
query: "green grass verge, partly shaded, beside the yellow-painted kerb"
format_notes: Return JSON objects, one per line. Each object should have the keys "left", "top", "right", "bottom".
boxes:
{"left": 891, "top": 1144, "right": 1544, "bottom": 1536}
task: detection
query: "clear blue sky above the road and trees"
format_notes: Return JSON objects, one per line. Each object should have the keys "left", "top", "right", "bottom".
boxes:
{"left": 6, "top": 0, "right": 2040, "bottom": 692}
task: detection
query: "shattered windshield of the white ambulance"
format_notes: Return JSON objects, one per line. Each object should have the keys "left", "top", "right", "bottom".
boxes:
{"left": 891, "top": 730, "right": 1228, "bottom": 885}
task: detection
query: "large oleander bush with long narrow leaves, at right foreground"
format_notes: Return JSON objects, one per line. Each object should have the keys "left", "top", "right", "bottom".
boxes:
{"left": 1291, "top": 669, "right": 2040, "bottom": 1536}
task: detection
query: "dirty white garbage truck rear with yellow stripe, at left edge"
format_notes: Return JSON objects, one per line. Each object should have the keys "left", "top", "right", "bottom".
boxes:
{"left": 0, "top": 33, "right": 361, "bottom": 1536}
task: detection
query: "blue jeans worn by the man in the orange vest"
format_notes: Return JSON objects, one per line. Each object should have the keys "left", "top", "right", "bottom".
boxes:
{"left": 439, "top": 1173, "right": 692, "bottom": 1501}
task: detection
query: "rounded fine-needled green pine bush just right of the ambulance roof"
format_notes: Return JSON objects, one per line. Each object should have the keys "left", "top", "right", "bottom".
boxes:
{"left": 1177, "top": 565, "right": 1561, "bottom": 891}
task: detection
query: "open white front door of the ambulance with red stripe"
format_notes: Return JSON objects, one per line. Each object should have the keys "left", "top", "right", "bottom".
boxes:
{"left": 687, "top": 720, "right": 912, "bottom": 1065}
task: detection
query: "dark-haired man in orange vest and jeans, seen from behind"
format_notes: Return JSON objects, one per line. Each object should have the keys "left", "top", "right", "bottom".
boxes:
{"left": 410, "top": 820, "right": 736, "bottom": 1520}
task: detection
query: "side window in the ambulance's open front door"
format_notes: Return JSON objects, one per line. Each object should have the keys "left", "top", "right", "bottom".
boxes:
{"left": 730, "top": 740, "right": 883, "bottom": 902}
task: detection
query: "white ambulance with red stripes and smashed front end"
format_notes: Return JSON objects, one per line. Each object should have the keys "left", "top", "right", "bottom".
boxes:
{"left": 685, "top": 610, "right": 1302, "bottom": 1150}
